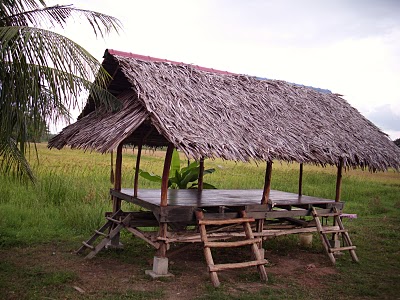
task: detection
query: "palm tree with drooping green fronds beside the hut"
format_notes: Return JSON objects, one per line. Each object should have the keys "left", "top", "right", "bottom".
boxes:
{"left": 0, "top": 0, "right": 121, "bottom": 181}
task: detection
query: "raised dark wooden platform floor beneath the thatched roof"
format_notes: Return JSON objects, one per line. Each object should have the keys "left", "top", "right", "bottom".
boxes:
{"left": 110, "top": 189, "right": 344, "bottom": 225}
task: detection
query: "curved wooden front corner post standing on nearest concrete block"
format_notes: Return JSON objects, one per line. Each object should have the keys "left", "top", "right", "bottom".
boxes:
{"left": 157, "top": 143, "right": 174, "bottom": 258}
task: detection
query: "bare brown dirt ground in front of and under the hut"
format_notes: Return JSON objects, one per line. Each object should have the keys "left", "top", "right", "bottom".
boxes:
{"left": 1, "top": 243, "right": 336, "bottom": 299}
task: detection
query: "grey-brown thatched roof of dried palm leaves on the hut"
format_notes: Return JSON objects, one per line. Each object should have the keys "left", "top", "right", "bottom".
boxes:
{"left": 49, "top": 50, "right": 400, "bottom": 170}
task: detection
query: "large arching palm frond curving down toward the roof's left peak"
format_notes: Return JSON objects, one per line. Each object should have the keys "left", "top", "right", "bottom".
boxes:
{"left": 0, "top": 26, "right": 115, "bottom": 107}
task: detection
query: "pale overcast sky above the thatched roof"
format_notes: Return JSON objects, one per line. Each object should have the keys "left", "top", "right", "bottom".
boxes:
{"left": 47, "top": 0, "right": 400, "bottom": 139}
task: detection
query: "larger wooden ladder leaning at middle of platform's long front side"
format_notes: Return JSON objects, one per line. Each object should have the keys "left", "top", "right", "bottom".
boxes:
{"left": 196, "top": 210, "right": 268, "bottom": 287}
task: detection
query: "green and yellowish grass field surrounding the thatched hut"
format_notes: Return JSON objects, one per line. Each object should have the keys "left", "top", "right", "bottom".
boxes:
{"left": 0, "top": 144, "right": 400, "bottom": 299}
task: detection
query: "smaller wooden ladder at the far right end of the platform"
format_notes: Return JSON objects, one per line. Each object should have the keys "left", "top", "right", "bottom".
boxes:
{"left": 312, "top": 207, "right": 358, "bottom": 264}
